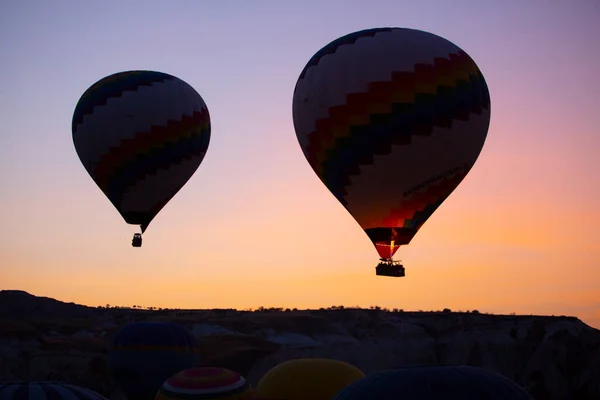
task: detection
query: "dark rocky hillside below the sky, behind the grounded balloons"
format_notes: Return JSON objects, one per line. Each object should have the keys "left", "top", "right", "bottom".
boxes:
{"left": 0, "top": 290, "right": 600, "bottom": 399}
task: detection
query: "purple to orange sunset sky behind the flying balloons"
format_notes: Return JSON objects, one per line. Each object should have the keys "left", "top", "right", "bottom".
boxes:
{"left": 0, "top": 0, "right": 600, "bottom": 328}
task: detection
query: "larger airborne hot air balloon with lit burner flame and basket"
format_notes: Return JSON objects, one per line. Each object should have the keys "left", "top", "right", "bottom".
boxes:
{"left": 292, "top": 28, "right": 490, "bottom": 276}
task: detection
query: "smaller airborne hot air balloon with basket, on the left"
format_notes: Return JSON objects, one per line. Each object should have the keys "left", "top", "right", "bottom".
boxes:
{"left": 72, "top": 71, "right": 211, "bottom": 247}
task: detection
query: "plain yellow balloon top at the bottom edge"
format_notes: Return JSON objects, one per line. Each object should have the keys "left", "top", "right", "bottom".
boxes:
{"left": 256, "top": 358, "right": 365, "bottom": 400}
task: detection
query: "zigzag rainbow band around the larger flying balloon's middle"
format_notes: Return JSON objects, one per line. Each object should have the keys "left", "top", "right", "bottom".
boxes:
{"left": 305, "top": 52, "right": 490, "bottom": 206}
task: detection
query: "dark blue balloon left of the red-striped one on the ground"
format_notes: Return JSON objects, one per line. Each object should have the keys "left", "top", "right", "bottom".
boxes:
{"left": 108, "top": 322, "right": 197, "bottom": 400}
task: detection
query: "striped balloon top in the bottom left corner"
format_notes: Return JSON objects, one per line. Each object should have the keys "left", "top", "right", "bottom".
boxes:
{"left": 0, "top": 381, "right": 107, "bottom": 400}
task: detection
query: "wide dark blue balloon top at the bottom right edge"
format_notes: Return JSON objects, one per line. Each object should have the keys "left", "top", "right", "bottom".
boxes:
{"left": 335, "top": 366, "right": 531, "bottom": 400}
